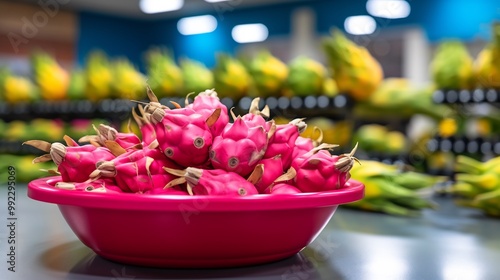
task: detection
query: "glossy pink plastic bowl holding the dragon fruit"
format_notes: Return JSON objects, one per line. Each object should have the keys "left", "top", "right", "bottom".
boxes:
{"left": 28, "top": 177, "right": 364, "bottom": 268}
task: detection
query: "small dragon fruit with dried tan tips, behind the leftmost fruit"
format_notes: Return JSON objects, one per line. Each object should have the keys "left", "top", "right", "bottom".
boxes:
{"left": 78, "top": 124, "right": 142, "bottom": 150}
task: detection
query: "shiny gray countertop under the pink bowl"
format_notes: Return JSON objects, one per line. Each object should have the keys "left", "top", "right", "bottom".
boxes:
{"left": 0, "top": 185, "right": 500, "bottom": 280}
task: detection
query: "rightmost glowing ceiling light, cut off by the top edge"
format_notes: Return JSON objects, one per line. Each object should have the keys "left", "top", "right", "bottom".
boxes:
{"left": 366, "top": 0, "right": 411, "bottom": 19}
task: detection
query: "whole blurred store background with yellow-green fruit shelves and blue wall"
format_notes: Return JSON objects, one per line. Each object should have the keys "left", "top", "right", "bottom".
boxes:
{"left": 0, "top": 0, "right": 500, "bottom": 217}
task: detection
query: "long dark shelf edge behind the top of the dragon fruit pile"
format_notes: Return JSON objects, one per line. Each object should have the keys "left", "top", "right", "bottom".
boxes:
{"left": 0, "top": 95, "right": 353, "bottom": 121}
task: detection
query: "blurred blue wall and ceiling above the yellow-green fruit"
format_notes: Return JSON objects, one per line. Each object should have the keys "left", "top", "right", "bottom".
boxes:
{"left": 0, "top": 0, "right": 500, "bottom": 77}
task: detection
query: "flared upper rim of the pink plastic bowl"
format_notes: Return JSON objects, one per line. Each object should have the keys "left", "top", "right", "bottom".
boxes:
{"left": 27, "top": 176, "right": 364, "bottom": 211}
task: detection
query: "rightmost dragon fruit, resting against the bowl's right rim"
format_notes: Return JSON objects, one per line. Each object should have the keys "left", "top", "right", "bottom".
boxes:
{"left": 292, "top": 144, "right": 358, "bottom": 192}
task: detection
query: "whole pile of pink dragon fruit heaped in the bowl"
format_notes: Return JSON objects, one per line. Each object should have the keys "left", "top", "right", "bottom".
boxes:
{"left": 25, "top": 88, "right": 357, "bottom": 196}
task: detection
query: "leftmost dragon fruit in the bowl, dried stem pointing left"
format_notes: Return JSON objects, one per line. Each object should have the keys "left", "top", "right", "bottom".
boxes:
{"left": 23, "top": 136, "right": 115, "bottom": 182}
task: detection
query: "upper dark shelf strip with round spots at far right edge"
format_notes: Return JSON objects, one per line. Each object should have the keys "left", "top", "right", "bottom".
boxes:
{"left": 432, "top": 89, "right": 500, "bottom": 104}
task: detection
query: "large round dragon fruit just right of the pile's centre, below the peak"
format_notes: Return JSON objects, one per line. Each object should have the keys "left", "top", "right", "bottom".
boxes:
{"left": 210, "top": 117, "right": 268, "bottom": 177}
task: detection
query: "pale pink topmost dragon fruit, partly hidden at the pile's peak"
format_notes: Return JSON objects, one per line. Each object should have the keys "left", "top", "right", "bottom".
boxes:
{"left": 185, "top": 89, "right": 229, "bottom": 137}
